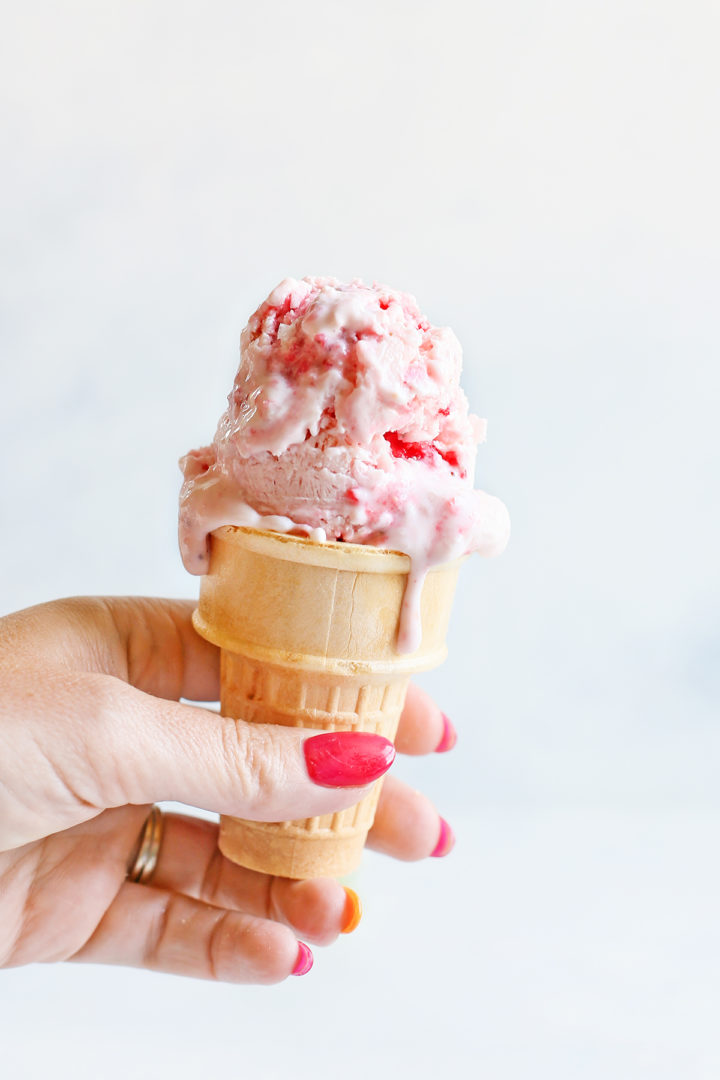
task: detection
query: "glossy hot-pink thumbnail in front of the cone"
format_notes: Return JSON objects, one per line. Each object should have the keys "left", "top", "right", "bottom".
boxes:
{"left": 303, "top": 731, "right": 395, "bottom": 787}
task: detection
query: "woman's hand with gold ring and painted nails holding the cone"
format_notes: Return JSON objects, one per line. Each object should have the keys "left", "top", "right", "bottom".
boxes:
{"left": 0, "top": 598, "right": 454, "bottom": 983}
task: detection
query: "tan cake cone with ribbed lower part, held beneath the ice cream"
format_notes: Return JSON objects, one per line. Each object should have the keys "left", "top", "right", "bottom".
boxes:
{"left": 193, "top": 526, "right": 459, "bottom": 878}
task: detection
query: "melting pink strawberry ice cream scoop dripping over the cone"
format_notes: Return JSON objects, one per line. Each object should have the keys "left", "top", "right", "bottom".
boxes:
{"left": 179, "top": 278, "right": 510, "bottom": 651}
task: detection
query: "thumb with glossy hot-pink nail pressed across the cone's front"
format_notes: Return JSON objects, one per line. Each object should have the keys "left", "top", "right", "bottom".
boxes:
{"left": 89, "top": 676, "right": 395, "bottom": 821}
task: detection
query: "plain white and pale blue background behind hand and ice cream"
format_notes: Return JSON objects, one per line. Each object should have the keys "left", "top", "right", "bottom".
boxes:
{"left": 0, "top": 0, "right": 720, "bottom": 1080}
